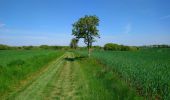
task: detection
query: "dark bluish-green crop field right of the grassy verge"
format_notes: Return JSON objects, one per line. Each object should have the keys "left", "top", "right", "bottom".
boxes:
{"left": 79, "top": 49, "right": 170, "bottom": 100}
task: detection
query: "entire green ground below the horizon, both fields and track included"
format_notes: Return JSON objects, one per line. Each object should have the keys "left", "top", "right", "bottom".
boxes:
{"left": 0, "top": 49, "right": 170, "bottom": 100}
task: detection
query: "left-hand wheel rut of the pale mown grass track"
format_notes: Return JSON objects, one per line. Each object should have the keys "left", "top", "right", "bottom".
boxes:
{"left": 8, "top": 54, "right": 66, "bottom": 100}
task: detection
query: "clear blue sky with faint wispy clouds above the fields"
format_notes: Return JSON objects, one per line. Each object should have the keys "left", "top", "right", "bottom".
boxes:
{"left": 0, "top": 0, "right": 170, "bottom": 46}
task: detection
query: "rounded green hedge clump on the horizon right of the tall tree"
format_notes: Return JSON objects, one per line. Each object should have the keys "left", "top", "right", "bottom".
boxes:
{"left": 104, "top": 43, "right": 139, "bottom": 51}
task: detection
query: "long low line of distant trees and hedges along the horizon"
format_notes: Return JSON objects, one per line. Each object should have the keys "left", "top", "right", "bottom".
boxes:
{"left": 0, "top": 43, "right": 170, "bottom": 51}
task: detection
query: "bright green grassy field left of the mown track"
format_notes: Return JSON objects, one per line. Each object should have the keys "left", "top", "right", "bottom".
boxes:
{"left": 0, "top": 50, "right": 63, "bottom": 97}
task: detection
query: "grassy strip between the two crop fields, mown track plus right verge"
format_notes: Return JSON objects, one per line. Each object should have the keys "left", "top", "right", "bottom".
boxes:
{"left": 1, "top": 52, "right": 142, "bottom": 100}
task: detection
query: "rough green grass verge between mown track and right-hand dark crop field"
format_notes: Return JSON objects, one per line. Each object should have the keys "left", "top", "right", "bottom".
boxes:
{"left": 75, "top": 52, "right": 143, "bottom": 100}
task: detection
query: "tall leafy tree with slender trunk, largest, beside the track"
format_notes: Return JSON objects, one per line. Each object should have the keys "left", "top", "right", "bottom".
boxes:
{"left": 72, "top": 15, "right": 100, "bottom": 56}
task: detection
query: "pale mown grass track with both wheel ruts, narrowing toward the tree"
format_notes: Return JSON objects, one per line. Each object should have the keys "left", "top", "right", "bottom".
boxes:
{"left": 8, "top": 52, "right": 88, "bottom": 100}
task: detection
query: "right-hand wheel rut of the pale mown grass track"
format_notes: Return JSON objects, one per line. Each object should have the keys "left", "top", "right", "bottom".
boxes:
{"left": 45, "top": 54, "right": 85, "bottom": 100}
